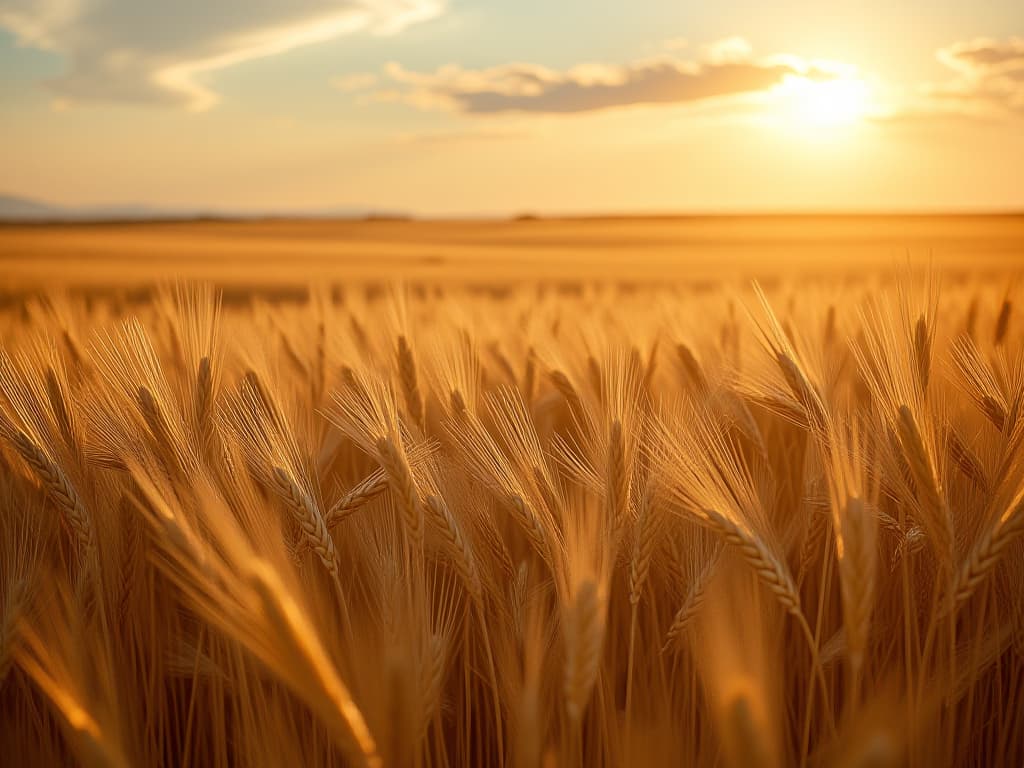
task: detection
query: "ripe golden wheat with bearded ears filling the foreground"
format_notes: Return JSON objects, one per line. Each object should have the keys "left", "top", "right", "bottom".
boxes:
{"left": 0, "top": 269, "right": 1024, "bottom": 767}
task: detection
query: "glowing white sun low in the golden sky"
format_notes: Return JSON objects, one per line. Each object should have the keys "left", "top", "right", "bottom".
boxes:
{"left": 776, "top": 77, "right": 869, "bottom": 128}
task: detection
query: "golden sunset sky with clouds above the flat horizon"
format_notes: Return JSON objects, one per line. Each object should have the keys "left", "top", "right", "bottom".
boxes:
{"left": 0, "top": 0, "right": 1024, "bottom": 216}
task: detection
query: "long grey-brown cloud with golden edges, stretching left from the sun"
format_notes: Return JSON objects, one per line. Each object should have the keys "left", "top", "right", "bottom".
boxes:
{"left": 368, "top": 38, "right": 830, "bottom": 114}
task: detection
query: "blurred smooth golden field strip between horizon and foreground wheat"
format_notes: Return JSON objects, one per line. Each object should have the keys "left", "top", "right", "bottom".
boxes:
{"left": 0, "top": 215, "right": 1024, "bottom": 288}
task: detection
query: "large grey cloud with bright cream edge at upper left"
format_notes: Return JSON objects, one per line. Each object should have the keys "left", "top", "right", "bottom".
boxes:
{"left": 0, "top": 0, "right": 441, "bottom": 110}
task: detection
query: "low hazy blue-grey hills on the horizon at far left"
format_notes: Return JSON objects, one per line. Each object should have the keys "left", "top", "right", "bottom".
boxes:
{"left": 0, "top": 195, "right": 411, "bottom": 222}
